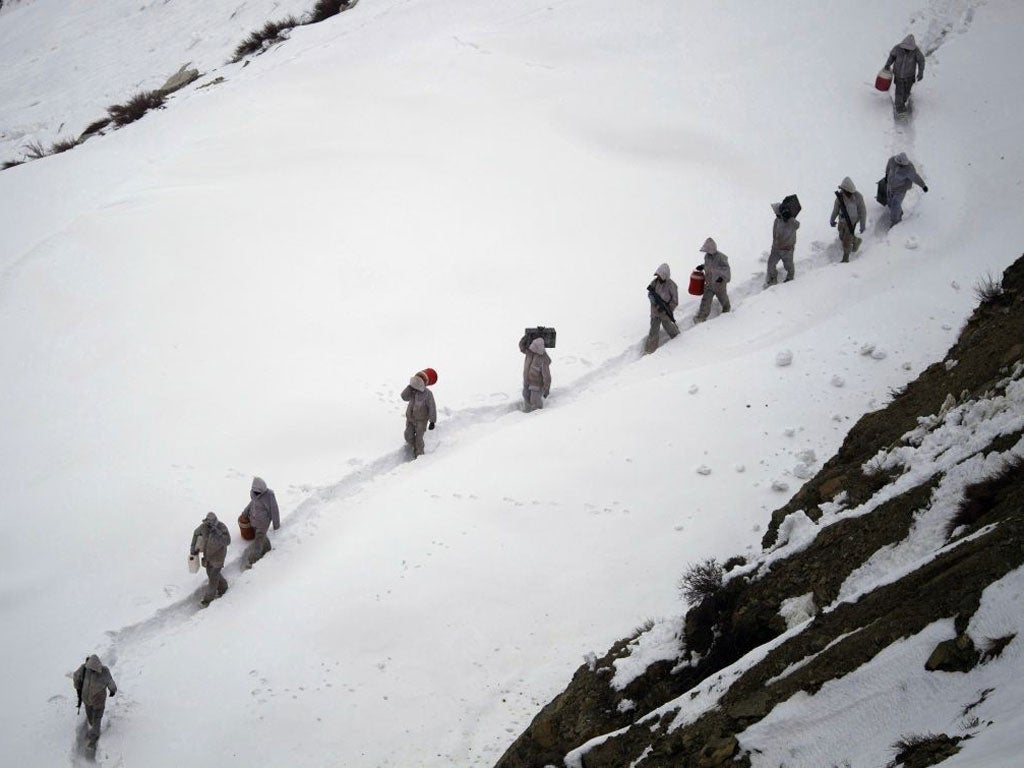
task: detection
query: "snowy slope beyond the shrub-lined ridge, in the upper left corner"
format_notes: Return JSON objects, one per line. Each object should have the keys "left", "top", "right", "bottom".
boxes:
{"left": 0, "top": 0, "right": 313, "bottom": 161}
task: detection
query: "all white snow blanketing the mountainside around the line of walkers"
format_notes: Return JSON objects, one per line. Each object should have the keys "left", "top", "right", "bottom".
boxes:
{"left": 0, "top": 0, "right": 1024, "bottom": 768}
